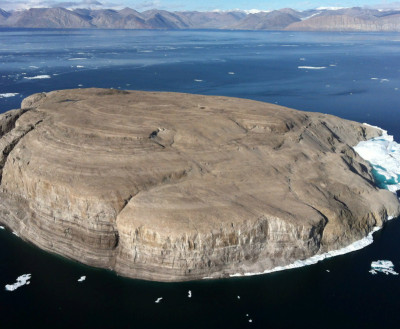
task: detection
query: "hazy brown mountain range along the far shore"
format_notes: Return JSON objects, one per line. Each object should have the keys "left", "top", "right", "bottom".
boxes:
{"left": 0, "top": 7, "right": 400, "bottom": 31}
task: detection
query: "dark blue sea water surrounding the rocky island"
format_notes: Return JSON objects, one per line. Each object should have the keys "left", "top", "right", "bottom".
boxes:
{"left": 0, "top": 29, "right": 400, "bottom": 329}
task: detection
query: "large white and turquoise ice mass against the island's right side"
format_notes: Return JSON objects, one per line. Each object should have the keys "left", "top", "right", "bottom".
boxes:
{"left": 354, "top": 128, "right": 400, "bottom": 193}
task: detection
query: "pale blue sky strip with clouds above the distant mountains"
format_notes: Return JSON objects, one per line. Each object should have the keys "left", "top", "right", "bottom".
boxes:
{"left": 0, "top": 0, "right": 400, "bottom": 11}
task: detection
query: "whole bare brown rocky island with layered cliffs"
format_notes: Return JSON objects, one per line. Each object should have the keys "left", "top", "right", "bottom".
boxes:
{"left": 0, "top": 89, "right": 400, "bottom": 281}
